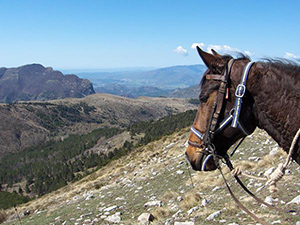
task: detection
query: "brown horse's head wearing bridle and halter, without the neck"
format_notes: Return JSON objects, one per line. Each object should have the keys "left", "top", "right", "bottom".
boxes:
{"left": 186, "top": 47, "right": 256, "bottom": 171}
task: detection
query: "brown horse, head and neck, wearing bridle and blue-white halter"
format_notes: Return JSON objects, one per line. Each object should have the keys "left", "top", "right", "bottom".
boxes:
{"left": 185, "top": 47, "right": 300, "bottom": 171}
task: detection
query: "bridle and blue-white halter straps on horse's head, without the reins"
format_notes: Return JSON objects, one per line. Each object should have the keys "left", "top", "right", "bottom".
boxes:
{"left": 188, "top": 58, "right": 254, "bottom": 171}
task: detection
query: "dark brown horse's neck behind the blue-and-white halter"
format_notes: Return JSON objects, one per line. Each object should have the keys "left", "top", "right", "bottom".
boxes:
{"left": 247, "top": 62, "right": 300, "bottom": 153}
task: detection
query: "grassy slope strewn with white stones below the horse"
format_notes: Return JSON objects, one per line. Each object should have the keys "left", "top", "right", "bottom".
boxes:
{"left": 5, "top": 129, "right": 300, "bottom": 225}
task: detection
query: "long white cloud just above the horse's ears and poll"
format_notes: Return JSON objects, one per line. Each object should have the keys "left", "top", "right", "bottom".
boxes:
{"left": 191, "top": 43, "right": 253, "bottom": 56}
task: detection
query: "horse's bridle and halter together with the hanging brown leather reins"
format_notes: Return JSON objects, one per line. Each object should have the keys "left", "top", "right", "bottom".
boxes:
{"left": 188, "top": 58, "right": 296, "bottom": 225}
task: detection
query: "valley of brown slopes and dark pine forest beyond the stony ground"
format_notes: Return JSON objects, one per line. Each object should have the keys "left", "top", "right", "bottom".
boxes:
{"left": 0, "top": 94, "right": 196, "bottom": 208}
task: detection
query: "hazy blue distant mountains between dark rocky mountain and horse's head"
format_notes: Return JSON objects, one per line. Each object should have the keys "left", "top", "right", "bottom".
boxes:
{"left": 78, "top": 65, "right": 206, "bottom": 96}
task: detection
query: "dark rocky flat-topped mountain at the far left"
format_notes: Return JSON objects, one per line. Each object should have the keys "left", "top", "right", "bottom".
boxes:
{"left": 0, "top": 64, "right": 95, "bottom": 103}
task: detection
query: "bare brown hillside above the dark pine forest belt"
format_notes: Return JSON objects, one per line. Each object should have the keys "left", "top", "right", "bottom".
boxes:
{"left": 0, "top": 94, "right": 195, "bottom": 158}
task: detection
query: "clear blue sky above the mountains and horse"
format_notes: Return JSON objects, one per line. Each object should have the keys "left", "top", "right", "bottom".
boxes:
{"left": 0, "top": 0, "right": 300, "bottom": 69}
